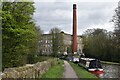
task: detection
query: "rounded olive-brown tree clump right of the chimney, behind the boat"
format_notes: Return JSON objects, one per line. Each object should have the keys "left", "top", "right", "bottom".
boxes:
{"left": 83, "top": 29, "right": 119, "bottom": 62}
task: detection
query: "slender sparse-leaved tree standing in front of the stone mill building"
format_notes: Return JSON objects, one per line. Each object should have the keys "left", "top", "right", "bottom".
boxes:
{"left": 50, "top": 27, "right": 64, "bottom": 57}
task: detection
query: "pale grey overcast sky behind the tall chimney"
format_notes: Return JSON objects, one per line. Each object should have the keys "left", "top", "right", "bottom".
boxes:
{"left": 34, "top": 0, "right": 117, "bottom": 35}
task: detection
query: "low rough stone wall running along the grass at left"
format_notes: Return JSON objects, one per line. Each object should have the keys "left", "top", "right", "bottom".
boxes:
{"left": 2, "top": 59, "right": 57, "bottom": 78}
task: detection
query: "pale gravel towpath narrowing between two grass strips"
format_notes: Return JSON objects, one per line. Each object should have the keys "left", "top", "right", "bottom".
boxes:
{"left": 64, "top": 61, "right": 78, "bottom": 78}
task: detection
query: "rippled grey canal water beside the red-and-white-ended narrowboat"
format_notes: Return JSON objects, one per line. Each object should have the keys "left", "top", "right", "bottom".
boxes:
{"left": 91, "top": 64, "right": 120, "bottom": 78}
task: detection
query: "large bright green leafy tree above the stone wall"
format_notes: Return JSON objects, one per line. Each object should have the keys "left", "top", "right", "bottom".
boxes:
{"left": 2, "top": 1, "right": 41, "bottom": 69}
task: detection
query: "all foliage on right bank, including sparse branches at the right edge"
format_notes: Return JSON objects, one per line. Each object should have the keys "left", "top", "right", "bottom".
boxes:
{"left": 84, "top": 2, "right": 120, "bottom": 62}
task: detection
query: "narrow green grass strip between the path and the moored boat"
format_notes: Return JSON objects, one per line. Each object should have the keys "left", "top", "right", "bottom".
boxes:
{"left": 69, "top": 62, "right": 97, "bottom": 79}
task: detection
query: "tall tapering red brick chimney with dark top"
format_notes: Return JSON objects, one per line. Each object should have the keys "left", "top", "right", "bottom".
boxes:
{"left": 72, "top": 4, "right": 77, "bottom": 53}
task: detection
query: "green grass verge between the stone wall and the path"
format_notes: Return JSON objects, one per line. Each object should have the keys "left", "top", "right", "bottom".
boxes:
{"left": 40, "top": 60, "right": 64, "bottom": 78}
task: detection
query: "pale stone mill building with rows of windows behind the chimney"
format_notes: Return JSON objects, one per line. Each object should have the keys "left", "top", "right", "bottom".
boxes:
{"left": 39, "top": 32, "right": 83, "bottom": 55}
